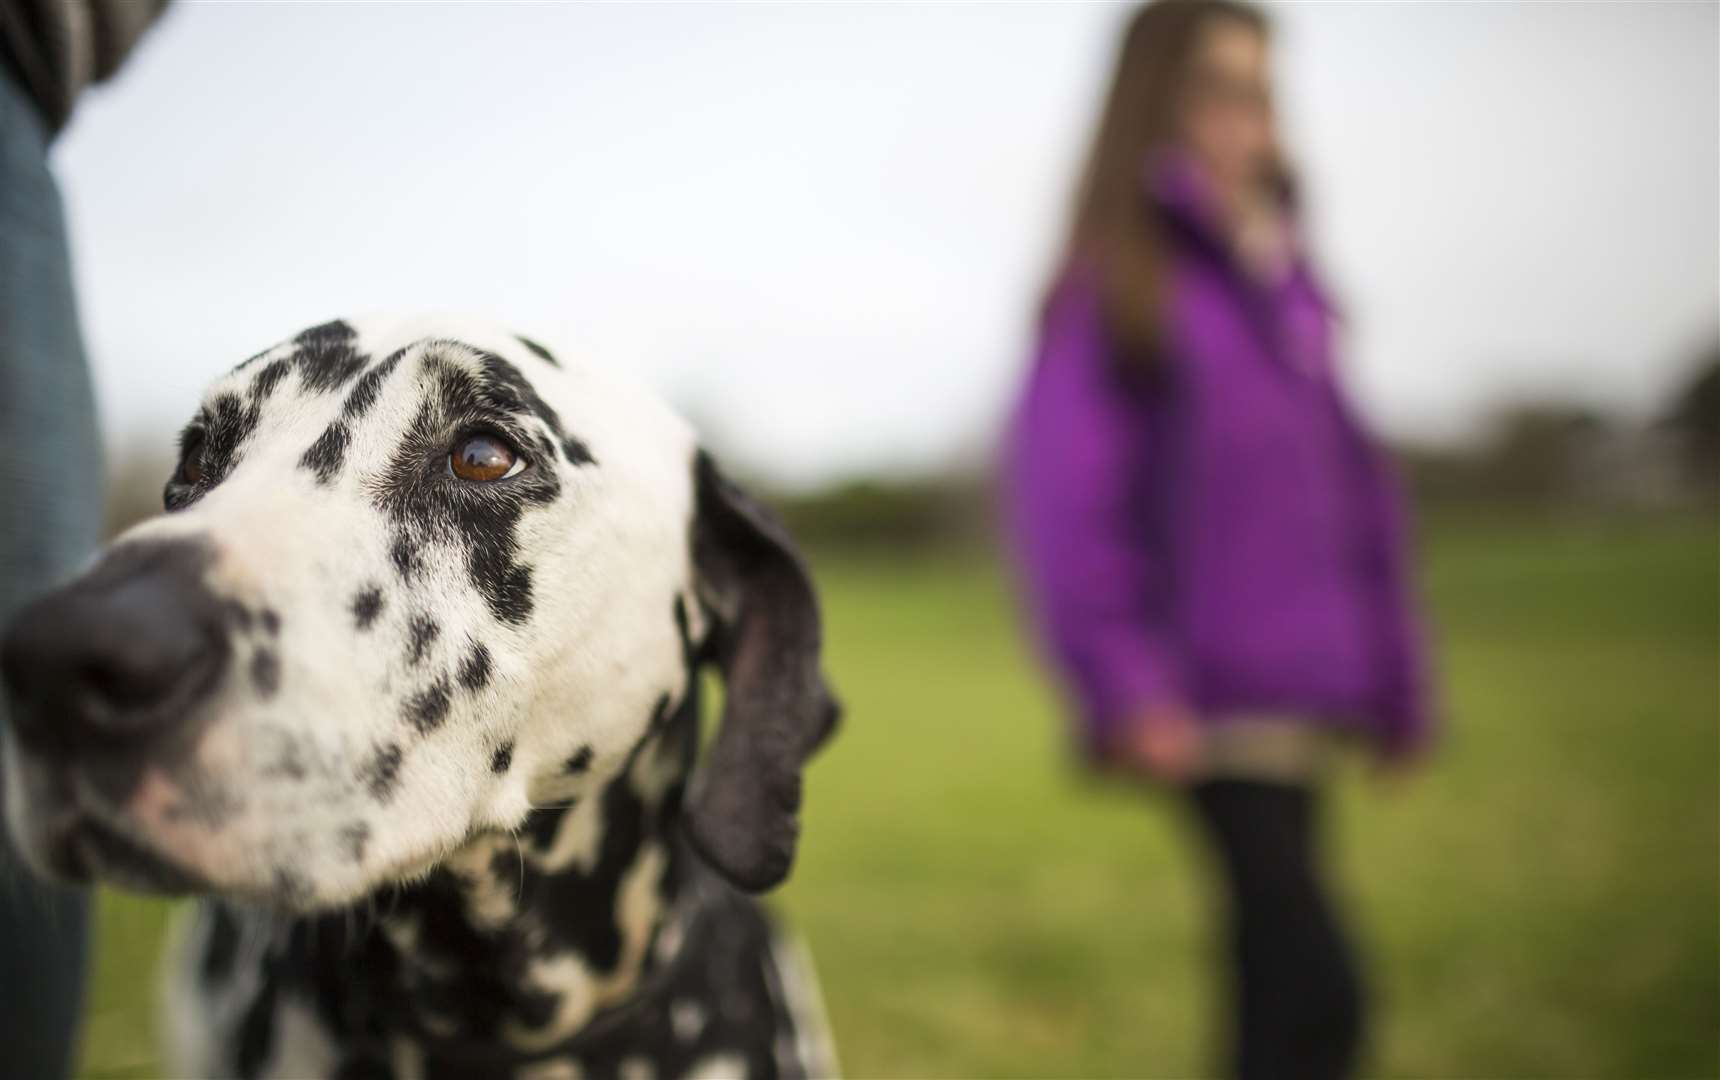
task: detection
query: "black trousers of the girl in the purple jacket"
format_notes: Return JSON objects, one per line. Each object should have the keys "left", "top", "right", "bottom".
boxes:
{"left": 1190, "top": 779, "right": 1362, "bottom": 1080}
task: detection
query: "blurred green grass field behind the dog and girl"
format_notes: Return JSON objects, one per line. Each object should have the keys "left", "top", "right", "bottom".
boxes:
{"left": 73, "top": 518, "right": 1720, "bottom": 1077}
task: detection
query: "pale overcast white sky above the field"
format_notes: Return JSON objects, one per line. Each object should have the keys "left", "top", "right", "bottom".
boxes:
{"left": 55, "top": 2, "right": 1720, "bottom": 485}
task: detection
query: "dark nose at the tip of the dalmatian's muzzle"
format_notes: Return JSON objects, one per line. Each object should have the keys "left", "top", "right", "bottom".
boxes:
{"left": 0, "top": 542, "right": 229, "bottom": 752}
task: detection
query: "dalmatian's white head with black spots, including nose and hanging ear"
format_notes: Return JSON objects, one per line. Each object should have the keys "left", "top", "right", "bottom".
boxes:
{"left": 3, "top": 322, "right": 834, "bottom": 908}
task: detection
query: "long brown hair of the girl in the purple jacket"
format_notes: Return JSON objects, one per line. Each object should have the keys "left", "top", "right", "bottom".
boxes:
{"left": 1060, "top": 0, "right": 1269, "bottom": 363}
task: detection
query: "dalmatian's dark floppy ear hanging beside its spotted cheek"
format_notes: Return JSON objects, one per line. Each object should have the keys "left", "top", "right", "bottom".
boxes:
{"left": 686, "top": 452, "right": 839, "bottom": 893}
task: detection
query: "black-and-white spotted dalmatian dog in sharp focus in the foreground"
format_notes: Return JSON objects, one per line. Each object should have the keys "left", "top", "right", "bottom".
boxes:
{"left": 0, "top": 318, "right": 836, "bottom": 1080}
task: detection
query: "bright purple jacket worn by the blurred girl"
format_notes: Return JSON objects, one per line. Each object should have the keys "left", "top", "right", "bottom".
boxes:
{"left": 1006, "top": 166, "right": 1429, "bottom": 753}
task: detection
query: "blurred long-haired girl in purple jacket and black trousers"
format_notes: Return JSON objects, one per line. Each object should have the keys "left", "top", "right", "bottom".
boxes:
{"left": 1008, "top": 0, "right": 1428, "bottom": 1080}
